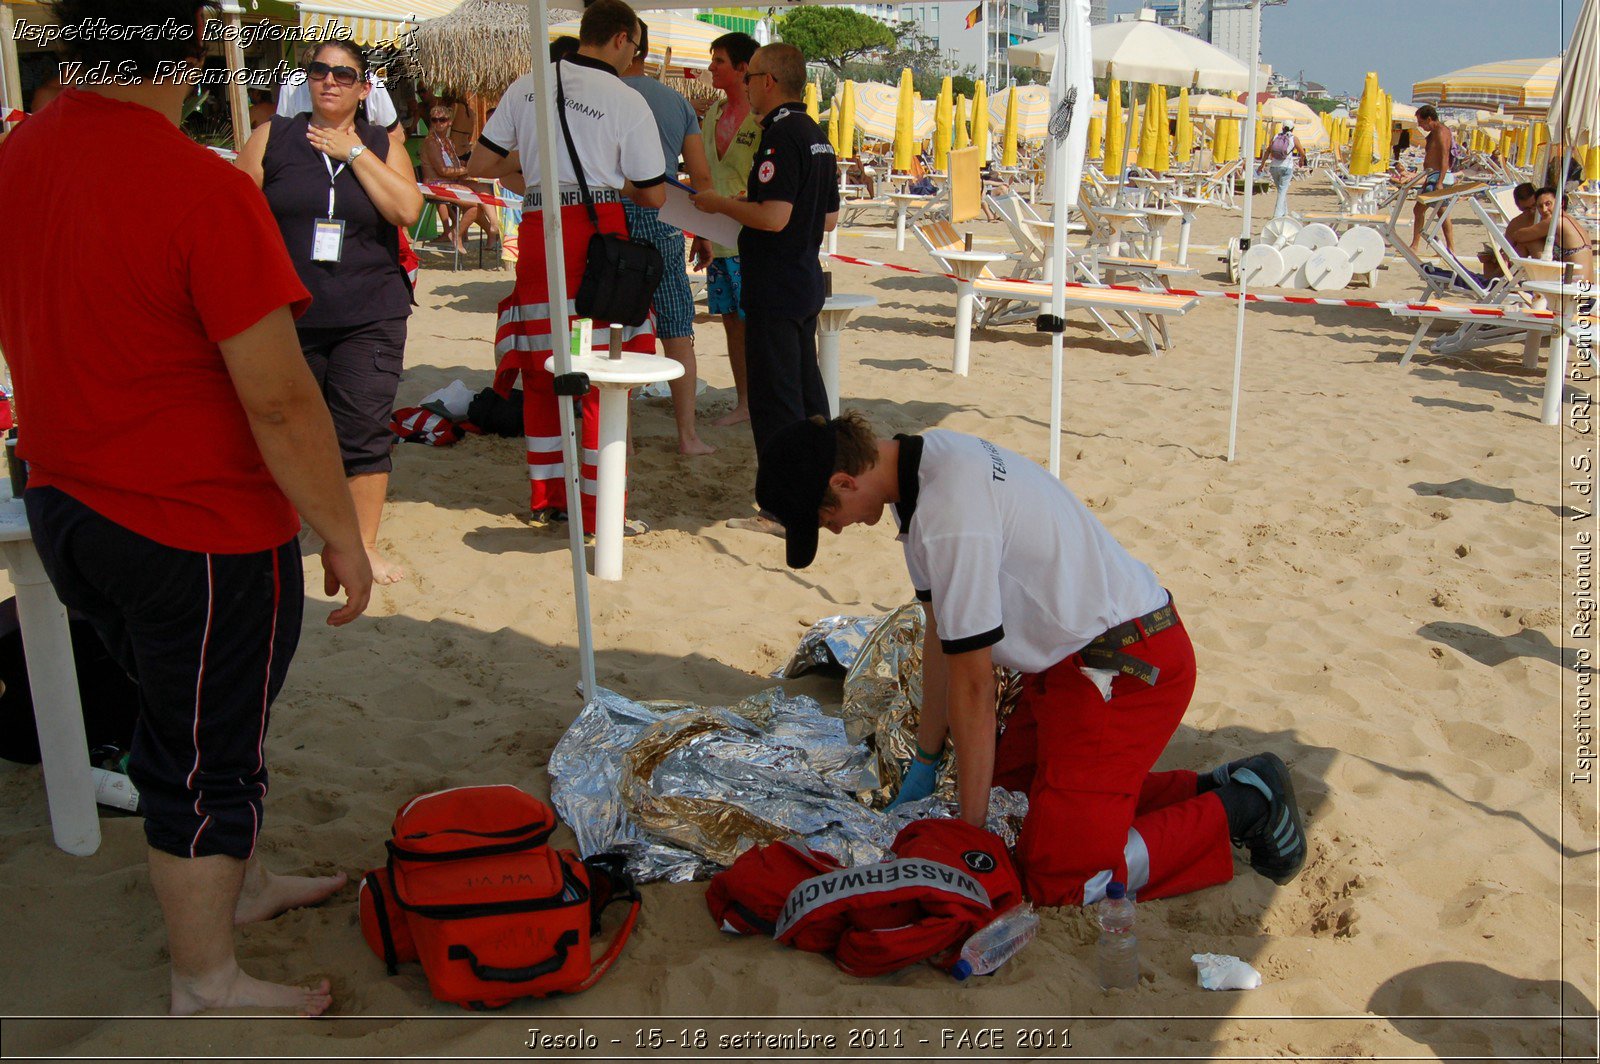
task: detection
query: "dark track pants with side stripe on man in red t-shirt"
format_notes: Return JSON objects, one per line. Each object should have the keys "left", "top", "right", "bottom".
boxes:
{"left": 24, "top": 488, "right": 306, "bottom": 859}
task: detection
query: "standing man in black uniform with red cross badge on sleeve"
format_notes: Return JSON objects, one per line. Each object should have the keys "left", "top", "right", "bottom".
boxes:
{"left": 694, "top": 45, "right": 838, "bottom": 531}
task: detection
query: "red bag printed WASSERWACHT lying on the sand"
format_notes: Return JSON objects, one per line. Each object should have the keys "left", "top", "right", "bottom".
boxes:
{"left": 706, "top": 819, "right": 1022, "bottom": 976}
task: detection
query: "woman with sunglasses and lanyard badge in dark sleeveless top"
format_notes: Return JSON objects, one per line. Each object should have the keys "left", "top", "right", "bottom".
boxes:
{"left": 238, "top": 42, "right": 422, "bottom": 584}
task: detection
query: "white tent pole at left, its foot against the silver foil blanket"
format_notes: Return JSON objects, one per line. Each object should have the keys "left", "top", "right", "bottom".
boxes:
{"left": 523, "top": 0, "right": 595, "bottom": 702}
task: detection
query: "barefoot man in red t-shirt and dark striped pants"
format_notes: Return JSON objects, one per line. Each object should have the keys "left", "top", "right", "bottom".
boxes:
{"left": 0, "top": 0, "right": 373, "bottom": 1016}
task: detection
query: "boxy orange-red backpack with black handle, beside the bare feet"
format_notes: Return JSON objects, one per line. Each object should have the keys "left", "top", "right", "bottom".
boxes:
{"left": 360, "top": 784, "right": 640, "bottom": 1008}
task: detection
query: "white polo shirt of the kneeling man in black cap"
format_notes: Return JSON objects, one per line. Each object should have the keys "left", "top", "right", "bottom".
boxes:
{"left": 894, "top": 429, "right": 1168, "bottom": 672}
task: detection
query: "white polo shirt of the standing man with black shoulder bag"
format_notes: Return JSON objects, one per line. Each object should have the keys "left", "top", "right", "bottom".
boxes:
{"left": 478, "top": 56, "right": 667, "bottom": 189}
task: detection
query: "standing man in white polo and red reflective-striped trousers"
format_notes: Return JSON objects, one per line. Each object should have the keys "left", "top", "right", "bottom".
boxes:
{"left": 467, "top": 0, "right": 667, "bottom": 531}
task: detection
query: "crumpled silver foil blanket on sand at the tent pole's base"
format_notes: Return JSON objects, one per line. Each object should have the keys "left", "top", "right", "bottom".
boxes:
{"left": 550, "top": 688, "right": 1027, "bottom": 882}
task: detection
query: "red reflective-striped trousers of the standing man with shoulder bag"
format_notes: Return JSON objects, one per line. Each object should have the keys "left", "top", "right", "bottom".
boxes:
{"left": 494, "top": 203, "right": 656, "bottom": 530}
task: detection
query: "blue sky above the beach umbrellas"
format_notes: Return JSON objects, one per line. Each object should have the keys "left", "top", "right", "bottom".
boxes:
{"left": 1107, "top": 0, "right": 1582, "bottom": 101}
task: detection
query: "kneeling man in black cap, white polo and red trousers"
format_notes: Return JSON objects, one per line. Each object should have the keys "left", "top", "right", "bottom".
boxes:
{"left": 755, "top": 411, "right": 1306, "bottom": 906}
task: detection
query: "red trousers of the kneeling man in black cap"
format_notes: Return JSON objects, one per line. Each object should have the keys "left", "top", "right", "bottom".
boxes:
{"left": 994, "top": 611, "right": 1234, "bottom": 906}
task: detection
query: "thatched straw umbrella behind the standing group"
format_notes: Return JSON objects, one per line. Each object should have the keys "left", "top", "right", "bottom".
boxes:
{"left": 414, "top": 0, "right": 571, "bottom": 101}
